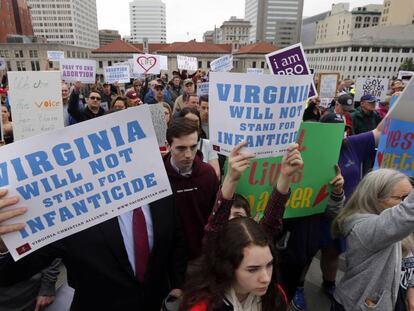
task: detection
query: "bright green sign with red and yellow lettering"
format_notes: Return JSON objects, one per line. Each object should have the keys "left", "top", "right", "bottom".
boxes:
{"left": 233, "top": 122, "right": 344, "bottom": 218}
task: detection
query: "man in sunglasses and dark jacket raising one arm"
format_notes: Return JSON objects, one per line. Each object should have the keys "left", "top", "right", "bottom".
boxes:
{"left": 68, "top": 81, "right": 105, "bottom": 122}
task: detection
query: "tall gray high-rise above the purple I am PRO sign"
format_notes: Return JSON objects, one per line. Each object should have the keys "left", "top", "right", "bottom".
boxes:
{"left": 245, "top": 0, "right": 303, "bottom": 47}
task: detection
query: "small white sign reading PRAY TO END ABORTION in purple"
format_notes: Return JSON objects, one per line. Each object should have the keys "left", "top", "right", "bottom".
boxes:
{"left": 60, "top": 58, "right": 96, "bottom": 83}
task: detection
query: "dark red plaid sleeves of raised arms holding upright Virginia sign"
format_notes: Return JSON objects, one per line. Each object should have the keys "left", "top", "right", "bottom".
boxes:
{"left": 203, "top": 187, "right": 291, "bottom": 245}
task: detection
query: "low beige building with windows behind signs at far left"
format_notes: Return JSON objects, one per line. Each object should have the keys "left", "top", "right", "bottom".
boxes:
{"left": 0, "top": 42, "right": 91, "bottom": 71}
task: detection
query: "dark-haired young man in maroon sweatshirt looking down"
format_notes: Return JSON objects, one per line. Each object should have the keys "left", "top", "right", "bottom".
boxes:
{"left": 164, "top": 118, "right": 219, "bottom": 260}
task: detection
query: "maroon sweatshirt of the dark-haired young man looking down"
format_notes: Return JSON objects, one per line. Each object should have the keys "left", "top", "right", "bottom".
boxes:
{"left": 164, "top": 151, "right": 219, "bottom": 260}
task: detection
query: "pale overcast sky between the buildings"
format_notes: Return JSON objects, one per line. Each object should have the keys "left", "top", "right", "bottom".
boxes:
{"left": 96, "top": 0, "right": 384, "bottom": 42}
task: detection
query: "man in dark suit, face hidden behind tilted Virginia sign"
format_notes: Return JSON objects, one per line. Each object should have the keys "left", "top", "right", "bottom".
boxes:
{"left": 0, "top": 190, "right": 186, "bottom": 311}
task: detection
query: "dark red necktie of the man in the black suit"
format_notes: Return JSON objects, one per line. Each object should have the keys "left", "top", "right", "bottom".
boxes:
{"left": 132, "top": 208, "right": 149, "bottom": 283}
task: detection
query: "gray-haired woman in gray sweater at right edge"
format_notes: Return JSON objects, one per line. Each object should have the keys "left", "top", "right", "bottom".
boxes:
{"left": 331, "top": 169, "right": 414, "bottom": 311}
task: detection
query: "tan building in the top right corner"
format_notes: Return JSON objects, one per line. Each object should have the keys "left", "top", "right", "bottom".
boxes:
{"left": 381, "top": 0, "right": 414, "bottom": 26}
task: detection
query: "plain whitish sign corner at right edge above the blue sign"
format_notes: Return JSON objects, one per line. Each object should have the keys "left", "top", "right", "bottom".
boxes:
{"left": 386, "top": 79, "right": 414, "bottom": 122}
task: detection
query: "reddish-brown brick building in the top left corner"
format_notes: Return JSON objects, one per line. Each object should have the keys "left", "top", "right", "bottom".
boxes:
{"left": 0, "top": 0, "right": 33, "bottom": 43}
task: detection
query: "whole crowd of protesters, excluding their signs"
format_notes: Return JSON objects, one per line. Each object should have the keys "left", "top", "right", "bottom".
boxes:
{"left": 0, "top": 70, "right": 414, "bottom": 311}
